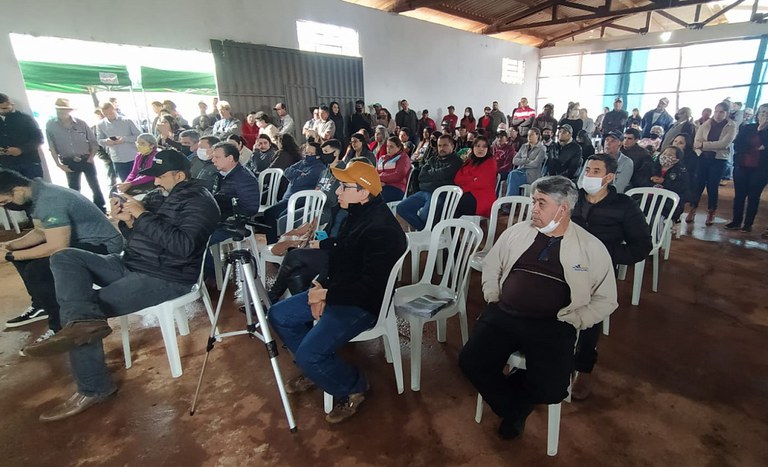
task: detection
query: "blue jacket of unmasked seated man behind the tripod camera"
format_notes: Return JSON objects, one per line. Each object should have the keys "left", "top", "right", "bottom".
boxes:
{"left": 213, "top": 164, "right": 261, "bottom": 220}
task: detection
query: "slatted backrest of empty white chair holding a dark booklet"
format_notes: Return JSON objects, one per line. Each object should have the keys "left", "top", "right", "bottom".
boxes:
{"left": 419, "top": 219, "right": 483, "bottom": 297}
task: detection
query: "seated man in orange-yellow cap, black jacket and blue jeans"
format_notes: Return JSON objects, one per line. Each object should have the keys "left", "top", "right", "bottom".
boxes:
{"left": 269, "top": 162, "right": 406, "bottom": 423}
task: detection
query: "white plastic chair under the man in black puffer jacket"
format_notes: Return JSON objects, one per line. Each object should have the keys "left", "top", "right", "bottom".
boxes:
{"left": 120, "top": 250, "right": 213, "bottom": 378}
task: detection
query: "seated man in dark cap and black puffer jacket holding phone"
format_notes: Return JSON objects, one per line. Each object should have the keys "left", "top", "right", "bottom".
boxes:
{"left": 25, "top": 150, "right": 219, "bottom": 422}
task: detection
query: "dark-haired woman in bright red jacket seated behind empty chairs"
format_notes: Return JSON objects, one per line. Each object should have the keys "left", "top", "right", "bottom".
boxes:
{"left": 453, "top": 136, "right": 498, "bottom": 217}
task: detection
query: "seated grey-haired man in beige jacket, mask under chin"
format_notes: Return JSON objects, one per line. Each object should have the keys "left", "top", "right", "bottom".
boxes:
{"left": 459, "top": 176, "right": 618, "bottom": 439}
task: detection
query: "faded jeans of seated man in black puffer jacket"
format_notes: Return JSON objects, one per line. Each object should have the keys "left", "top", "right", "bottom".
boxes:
{"left": 51, "top": 248, "right": 192, "bottom": 396}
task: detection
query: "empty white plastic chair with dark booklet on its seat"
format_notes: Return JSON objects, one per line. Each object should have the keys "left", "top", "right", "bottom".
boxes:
{"left": 393, "top": 219, "right": 483, "bottom": 391}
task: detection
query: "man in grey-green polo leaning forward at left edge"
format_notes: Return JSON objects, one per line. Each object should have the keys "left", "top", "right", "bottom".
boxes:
{"left": 0, "top": 169, "right": 123, "bottom": 355}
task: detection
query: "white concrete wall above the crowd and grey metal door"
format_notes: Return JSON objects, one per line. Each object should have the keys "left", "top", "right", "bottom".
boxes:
{"left": 0, "top": 0, "right": 539, "bottom": 120}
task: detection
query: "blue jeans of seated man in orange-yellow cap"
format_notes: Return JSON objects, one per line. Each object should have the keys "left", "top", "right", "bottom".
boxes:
{"left": 269, "top": 292, "right": 378, "bottom": 398}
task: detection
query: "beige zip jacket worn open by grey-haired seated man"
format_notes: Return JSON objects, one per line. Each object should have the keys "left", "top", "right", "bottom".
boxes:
{"left": 482, "top": 222, "right": 619, "bottom": 329}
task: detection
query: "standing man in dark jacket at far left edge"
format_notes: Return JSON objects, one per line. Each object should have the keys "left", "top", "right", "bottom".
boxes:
{"left": 0, "top": 93, "right": 43, "bottom": 178}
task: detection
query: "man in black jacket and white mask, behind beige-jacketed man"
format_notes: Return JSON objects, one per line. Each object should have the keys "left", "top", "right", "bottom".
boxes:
{"left": 571, "top": 154, "right": 653, "bottom": 400}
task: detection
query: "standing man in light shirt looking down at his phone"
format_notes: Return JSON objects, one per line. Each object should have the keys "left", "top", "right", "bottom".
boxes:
{"left": 96, "top": 102, "right": 141, "bottom": 182}
